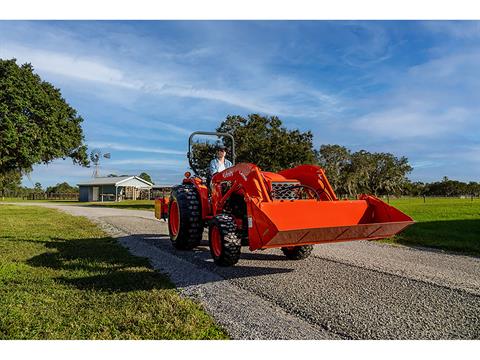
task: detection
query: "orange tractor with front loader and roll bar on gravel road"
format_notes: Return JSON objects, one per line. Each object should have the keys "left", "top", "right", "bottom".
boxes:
{"left": 155, "top": 131, "right": 414, "bottom": 266}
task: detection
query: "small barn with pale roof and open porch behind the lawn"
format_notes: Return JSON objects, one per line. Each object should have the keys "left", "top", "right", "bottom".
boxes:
{"left": 77, "top": 175, "right": 153, "bottom": 201}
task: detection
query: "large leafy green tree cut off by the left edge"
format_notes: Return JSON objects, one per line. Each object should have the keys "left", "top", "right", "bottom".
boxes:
{"left": 0, "top": 59, "right": 89, "bottom": 180}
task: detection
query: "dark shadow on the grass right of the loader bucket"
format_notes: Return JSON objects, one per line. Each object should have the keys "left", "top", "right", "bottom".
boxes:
{"left": 393, "top": 215, "right": 480, "bottom": 256}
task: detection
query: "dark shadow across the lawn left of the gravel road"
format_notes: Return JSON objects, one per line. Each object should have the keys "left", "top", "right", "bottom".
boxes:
{"left": 27, "top": 238, "right": 174, "bottom": 292}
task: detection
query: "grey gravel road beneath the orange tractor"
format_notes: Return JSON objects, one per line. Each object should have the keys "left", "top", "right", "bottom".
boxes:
{"left": 7, "top": 203, "right": 480, "bottom": 339}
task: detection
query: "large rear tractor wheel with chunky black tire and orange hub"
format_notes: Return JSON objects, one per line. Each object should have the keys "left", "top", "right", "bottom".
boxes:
{"left": 168, "top": 184, "right": 203, "bottom": 250}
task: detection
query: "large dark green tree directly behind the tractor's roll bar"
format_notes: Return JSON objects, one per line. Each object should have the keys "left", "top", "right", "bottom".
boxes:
{"left": 217, "top": 114, "right": 316, "bottom": 171}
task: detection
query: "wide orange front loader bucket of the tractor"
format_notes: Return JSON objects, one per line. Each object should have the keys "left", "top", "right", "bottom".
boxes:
{"left": 249, "top": 195, "right": 414, "bottom": 250}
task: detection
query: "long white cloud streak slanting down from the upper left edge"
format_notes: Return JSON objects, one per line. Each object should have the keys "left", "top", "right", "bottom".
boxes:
{"left": 0, "top": 43, "right": 338, "bottom": 119}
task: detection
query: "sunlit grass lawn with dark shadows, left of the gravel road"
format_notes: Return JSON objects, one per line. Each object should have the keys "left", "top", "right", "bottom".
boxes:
{"left": 0, "top": 205, "right": 227, "bottom": 339}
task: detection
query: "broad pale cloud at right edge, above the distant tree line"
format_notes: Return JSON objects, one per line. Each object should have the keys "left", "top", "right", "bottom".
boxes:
{"left": 352, "top": 51, "right": 480, "bottom": 139}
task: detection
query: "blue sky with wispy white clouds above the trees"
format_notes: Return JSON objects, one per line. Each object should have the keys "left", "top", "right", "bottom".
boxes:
{"left": 0, "top": 21, "right": 480, "bottom": 187}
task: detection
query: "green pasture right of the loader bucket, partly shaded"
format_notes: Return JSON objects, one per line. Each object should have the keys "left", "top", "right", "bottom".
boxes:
{"left": 387, "top": 198, "right": 480, "bottom": 256}
